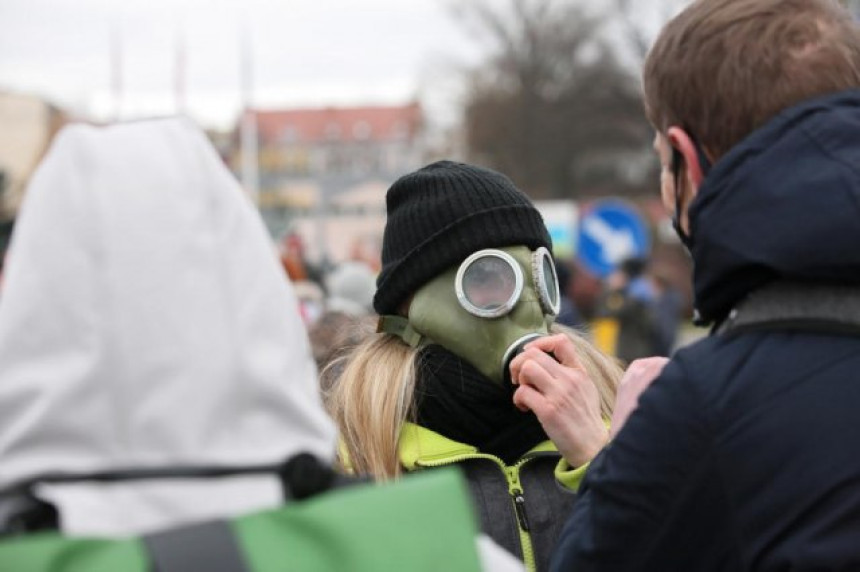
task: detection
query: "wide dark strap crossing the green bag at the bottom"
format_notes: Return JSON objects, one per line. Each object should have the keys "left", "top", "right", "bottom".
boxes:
{"left": 142, "top": 520, "right": 250, "bottom": 572}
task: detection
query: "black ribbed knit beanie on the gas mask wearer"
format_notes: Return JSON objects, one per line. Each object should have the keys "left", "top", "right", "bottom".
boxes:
{"left": 373, "top": 161, "right": 552, "bottom": 314}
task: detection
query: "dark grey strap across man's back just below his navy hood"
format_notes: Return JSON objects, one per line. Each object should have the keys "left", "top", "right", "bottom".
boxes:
{"left": 716, "top": 281, "right": 860, "bottom": 336}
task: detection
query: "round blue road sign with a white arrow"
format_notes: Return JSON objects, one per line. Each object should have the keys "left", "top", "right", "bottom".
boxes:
{"left": 578, "top": 200, "right": 651, "bottom": 278}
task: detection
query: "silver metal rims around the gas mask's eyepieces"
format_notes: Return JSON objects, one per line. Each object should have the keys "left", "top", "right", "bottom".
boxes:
{"left": 454, "top": 246, "right": 561, "bottom": 318}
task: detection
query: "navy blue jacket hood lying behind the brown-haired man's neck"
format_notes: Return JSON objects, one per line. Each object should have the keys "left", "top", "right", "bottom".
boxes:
{"left": 689, "top": 91, "right": 860, "bottom": 322}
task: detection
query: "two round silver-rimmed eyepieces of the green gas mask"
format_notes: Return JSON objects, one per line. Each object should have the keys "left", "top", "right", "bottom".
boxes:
{"left": 454, "top": 247, "right": 561, "bottom": 318}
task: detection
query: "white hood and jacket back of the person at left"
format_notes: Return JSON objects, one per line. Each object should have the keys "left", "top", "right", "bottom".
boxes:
{"left": 0, "top": 119, "right": 334, "bottom": 535}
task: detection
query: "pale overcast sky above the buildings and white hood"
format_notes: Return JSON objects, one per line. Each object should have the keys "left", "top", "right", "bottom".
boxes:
{"left": 0, "top": 0, "right": 684, "bottom": 127}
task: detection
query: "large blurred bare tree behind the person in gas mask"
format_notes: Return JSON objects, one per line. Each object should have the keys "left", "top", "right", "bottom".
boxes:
{"left": 459, "top": 0, "right": 650, "bottom": 198}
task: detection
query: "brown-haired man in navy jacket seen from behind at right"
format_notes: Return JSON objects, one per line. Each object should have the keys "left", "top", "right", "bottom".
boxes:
{"left": 532, "top": 0, "right": 860, "bottom": 572}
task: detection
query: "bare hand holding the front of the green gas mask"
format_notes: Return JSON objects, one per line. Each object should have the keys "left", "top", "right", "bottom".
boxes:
{"left": 511, "top": 334, "right": 609, "bottom": 467}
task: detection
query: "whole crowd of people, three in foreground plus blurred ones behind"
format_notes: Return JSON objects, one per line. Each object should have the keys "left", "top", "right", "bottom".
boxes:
{"left": 0, "top": 0, "right": 860, "bottom": 572}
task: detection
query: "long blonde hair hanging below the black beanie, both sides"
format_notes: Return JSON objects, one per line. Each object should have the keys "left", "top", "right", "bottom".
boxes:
{"left": 324, "top": 324, "right": 623, "bottom": 481}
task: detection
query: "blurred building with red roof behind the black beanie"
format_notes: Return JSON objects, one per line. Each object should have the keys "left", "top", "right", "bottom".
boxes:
{"left": 232, "top": 103, "right": 426, "bottom": 259}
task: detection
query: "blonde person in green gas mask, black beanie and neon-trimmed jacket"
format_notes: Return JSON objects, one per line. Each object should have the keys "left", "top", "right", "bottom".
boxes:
{"left": 326, "top": 161, "right": 621, "bottom": 570}
